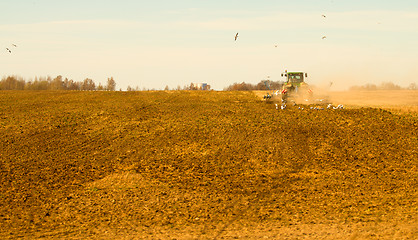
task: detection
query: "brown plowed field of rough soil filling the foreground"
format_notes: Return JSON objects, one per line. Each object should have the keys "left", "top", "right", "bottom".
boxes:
{"left": 0, "top": 91, "right": 418, "bottom": 239}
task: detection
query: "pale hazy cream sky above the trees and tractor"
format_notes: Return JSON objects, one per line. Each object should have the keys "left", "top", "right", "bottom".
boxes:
{"left": 0, "top": 0, "right": 418, "bottom": 90}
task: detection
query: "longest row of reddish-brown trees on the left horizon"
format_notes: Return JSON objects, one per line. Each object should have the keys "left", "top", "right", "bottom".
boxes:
{"left": 0, "top": 75, "right": 116, "bottom": 91}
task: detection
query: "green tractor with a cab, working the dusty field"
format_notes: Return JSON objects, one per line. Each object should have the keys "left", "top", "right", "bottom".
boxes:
{"left": 280, "top": 71, "right": 312, "bottom": 102}
